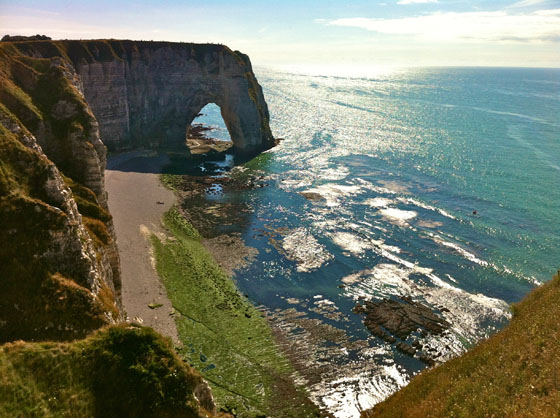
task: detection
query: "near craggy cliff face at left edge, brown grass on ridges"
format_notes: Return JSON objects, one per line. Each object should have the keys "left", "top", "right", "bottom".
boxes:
{"left": 0, "top": 43, "right": 122, "bottom": 341}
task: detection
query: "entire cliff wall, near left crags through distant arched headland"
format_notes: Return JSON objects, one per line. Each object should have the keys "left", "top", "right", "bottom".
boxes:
{"left": 0, "top": 40, "right": 275, "bottom": 341}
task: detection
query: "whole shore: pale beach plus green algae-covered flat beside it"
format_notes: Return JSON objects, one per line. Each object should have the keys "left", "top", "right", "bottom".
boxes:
{"left": 106, "top": 152, "right": 321, "bottom": 417}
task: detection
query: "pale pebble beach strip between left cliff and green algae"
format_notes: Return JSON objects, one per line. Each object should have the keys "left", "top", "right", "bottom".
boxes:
{"left": 105, "top": 151, "right": 180, "bottom": 345}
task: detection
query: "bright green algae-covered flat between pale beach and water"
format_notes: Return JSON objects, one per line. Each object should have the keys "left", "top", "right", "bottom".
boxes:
{"left": 152, "top": 207, "right": 317, "bottom": 417}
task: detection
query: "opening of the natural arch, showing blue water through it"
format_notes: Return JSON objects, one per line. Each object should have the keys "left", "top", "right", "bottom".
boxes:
{"left": 186, "top": 103, "right": 233, "bottom": 155}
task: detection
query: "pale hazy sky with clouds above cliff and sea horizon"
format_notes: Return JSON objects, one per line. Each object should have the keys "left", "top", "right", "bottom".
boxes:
{"left": 0, "top": 0, "right": 560, "bottom": 68}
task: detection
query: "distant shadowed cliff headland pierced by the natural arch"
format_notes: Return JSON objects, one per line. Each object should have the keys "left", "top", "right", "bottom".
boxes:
{"left": 14, "top": 40, "right": 276, "bottom": 154}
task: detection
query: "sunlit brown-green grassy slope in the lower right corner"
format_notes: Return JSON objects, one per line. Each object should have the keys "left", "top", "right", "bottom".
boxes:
{"left": 362, "top": 272, "right": 560, "bottom": 418}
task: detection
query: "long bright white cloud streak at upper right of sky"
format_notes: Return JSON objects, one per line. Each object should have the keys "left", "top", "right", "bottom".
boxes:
{"left": 327, "top": 9, "right": 560, "bottom": 42}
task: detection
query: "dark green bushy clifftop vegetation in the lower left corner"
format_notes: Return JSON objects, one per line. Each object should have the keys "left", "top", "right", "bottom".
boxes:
{"left": 0, "top": 325, "right": 212, "bottom": 418}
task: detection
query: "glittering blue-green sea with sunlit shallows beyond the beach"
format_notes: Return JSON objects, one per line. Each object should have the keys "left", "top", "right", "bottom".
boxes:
{"left": 191, "top": 67, "right": 560, "bottom": 417}
